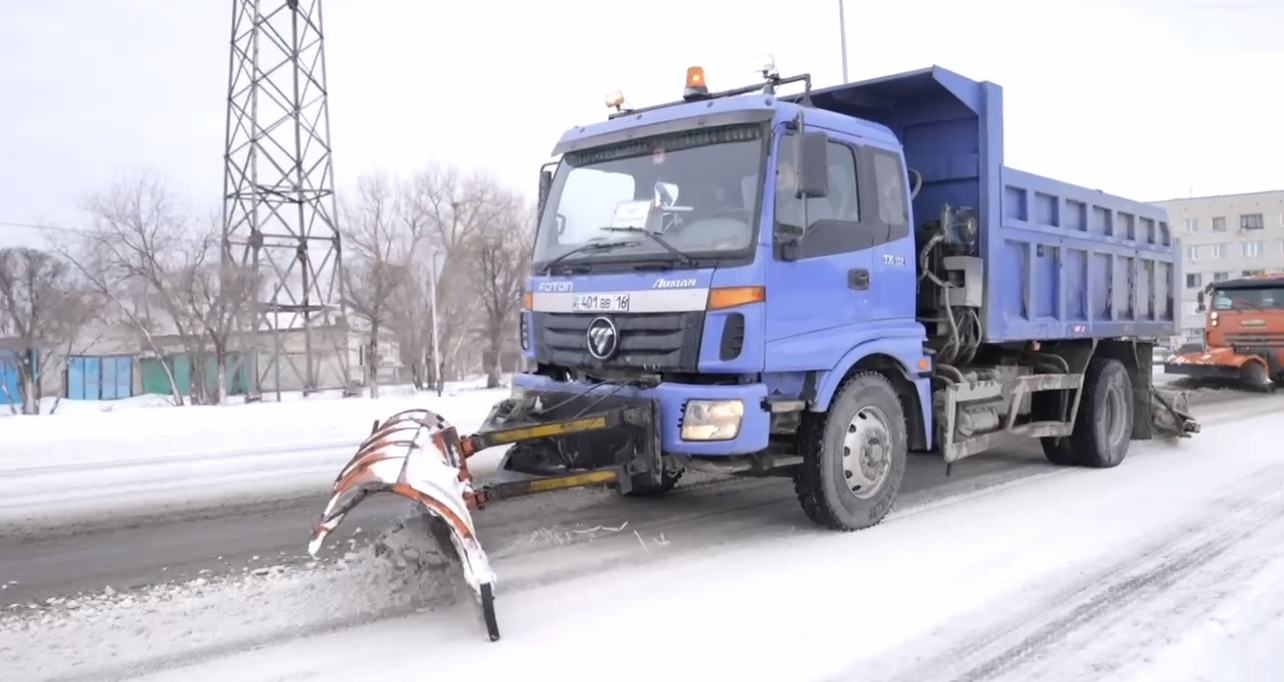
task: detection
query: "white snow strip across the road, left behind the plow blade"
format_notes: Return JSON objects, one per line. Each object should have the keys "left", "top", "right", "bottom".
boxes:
{"left": 0, "top": 384, "right": 508, "bottom": 525}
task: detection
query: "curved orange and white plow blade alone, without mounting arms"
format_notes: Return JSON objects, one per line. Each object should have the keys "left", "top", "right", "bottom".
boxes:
{"left": 308, "top": 410, "right": 499, "bottom": 641}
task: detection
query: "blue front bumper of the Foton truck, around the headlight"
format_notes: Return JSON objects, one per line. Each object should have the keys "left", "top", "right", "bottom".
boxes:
{"left": 512, "top": 374, "right": 772, "bottom": 456}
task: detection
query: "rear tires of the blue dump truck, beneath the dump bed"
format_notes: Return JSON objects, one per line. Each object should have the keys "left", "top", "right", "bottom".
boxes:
{"left": 1040, "top": 357, "right": 1134, "bottom": 469}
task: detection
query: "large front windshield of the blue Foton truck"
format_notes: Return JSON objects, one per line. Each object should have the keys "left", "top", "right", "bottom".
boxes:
{"left": 532, "top": 125, "right": 765, "bottom": 270}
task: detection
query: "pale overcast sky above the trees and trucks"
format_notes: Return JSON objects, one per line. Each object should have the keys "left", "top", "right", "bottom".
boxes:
{"left": 0, "top": 0, "right": 1284, "bottom": 245}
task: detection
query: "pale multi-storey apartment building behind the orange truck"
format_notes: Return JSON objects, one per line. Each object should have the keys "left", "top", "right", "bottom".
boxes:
{"left": 1154, "top": 190, "right": 1284, "bottom": 340}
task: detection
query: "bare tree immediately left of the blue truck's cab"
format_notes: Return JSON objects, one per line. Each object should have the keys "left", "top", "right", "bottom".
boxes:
{"left": 470, "top": 197, "right": 535, "bottom": 388}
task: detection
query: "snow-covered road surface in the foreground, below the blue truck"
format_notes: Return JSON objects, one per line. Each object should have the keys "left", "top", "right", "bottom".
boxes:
{"left": 0, "top": 398, "right": 1284, "bottom": 682}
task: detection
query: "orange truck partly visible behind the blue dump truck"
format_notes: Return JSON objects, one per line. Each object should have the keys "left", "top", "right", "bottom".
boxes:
{"left": 1163, "top": 274, "right": 1284, "bottom": 390}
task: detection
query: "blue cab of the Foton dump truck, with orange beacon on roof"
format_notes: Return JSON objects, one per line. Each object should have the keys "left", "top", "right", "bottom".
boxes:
{"left": 505, "top": 61, "right": 930, "bottom": 495}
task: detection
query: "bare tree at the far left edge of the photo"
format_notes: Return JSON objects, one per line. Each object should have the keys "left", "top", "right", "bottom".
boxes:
{"left": 0, "top": 248, "right": 91, "bottom": 415}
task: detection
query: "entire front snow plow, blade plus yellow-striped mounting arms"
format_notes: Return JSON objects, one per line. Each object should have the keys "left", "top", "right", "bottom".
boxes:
{"left": 308, "top": 396, "right": 663, "bottom": 641}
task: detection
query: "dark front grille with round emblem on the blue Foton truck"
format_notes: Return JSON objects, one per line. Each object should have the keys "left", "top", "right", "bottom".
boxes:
{"left": 534, "top": 311, "right": 705, "bottom": 371}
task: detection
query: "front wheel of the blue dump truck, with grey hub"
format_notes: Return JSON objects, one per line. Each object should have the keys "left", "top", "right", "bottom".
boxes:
{"left": 794, "top": 372, "right": 908, "bottom": 532}
